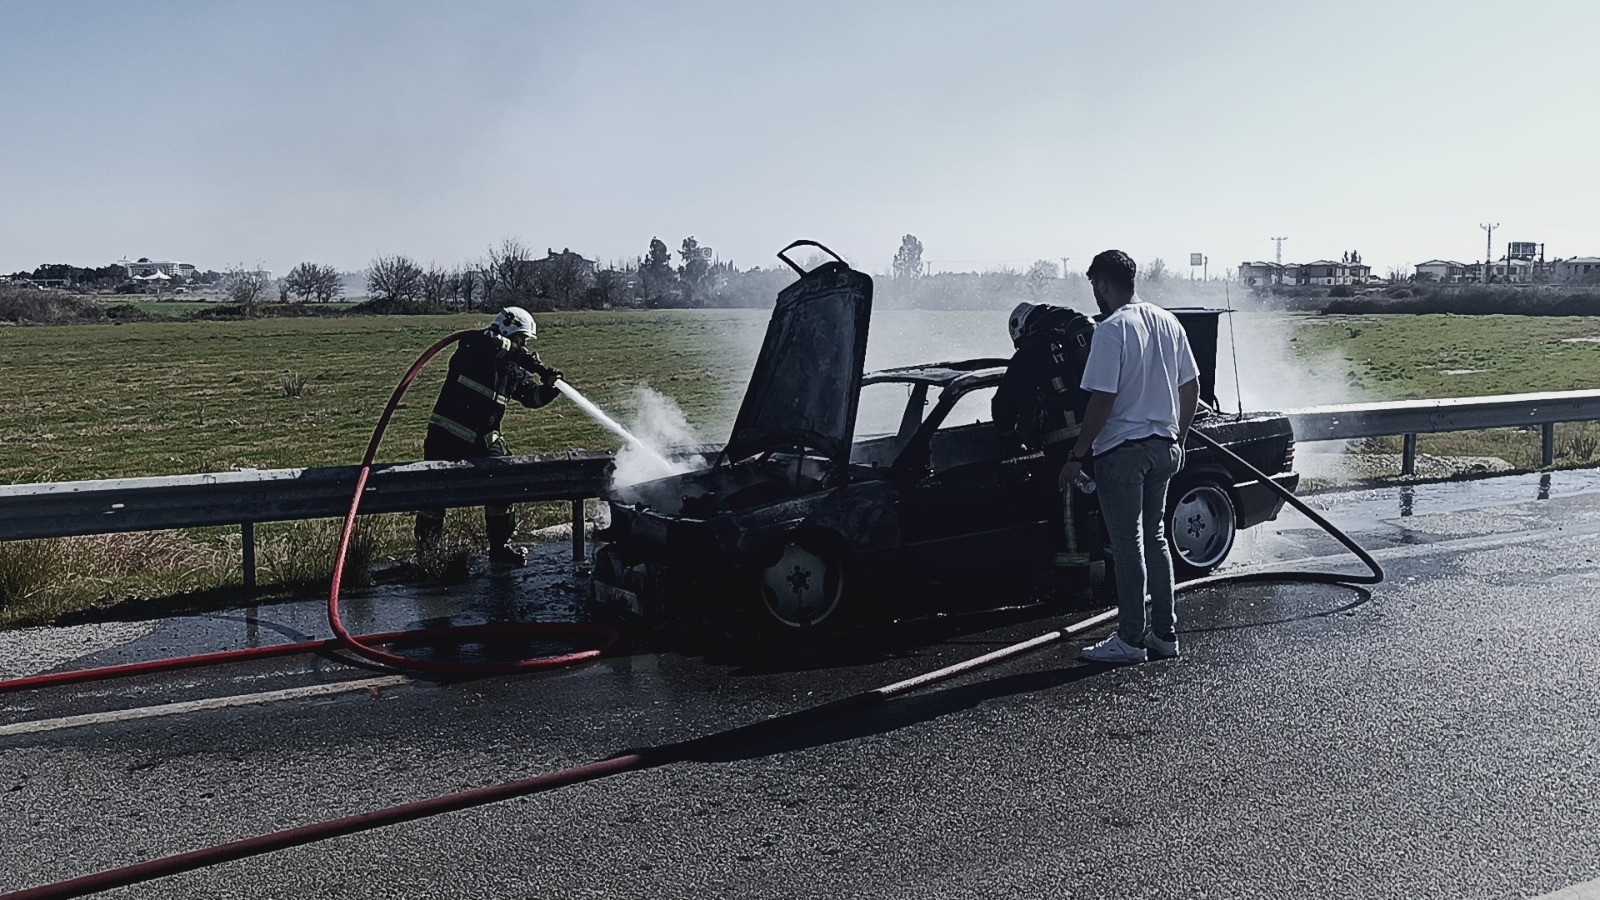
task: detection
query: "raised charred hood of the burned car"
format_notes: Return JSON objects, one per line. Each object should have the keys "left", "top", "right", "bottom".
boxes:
{"left": 723, "top": 240, "right": 872, "bottom": 471}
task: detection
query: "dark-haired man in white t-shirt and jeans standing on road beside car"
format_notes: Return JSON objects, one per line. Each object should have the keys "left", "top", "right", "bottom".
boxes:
{"left": 1061, "top": 250, "right": 1200, "bottom": 663}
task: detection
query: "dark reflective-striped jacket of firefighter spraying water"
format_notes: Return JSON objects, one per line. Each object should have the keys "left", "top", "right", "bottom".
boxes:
{"left": 429, "top": 330, "right": 558, "bottom": 448}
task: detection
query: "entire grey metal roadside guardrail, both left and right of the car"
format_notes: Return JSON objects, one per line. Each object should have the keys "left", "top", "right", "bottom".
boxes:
{"left": 0, "top": 391, "right": 1600, "bottom": 586}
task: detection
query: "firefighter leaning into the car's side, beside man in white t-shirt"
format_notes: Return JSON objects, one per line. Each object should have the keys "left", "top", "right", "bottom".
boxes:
{"left": 992, "top": 303, "right": 1094, "bottom": 591}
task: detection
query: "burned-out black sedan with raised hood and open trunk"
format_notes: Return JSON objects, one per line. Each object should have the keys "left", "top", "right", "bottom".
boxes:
{"left": 592, "top": 241, "right": 1299, "bottom": 634}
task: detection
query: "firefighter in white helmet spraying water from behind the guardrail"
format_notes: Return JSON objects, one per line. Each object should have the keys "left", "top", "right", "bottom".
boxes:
{"left": 416, "top": 306, "right": 562, "bottom": 565}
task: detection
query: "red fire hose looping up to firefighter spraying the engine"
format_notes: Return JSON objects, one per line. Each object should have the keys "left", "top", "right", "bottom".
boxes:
{"left": 0, "top": 331, "right": 621, "bottom": 693}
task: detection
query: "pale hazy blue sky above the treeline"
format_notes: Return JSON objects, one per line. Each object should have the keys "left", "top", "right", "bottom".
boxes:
{"left": 0, "top": 0, "right": 1600, "bottom": 274}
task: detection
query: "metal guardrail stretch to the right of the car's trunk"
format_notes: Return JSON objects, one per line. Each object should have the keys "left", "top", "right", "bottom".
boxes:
{"left": 1286, "top": 391, "right": 1600, "bottom": 476}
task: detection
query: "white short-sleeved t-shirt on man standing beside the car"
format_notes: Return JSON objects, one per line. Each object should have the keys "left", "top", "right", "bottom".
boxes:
{"left": 1082, "top": 296, "right": 1200, "bottom": 455}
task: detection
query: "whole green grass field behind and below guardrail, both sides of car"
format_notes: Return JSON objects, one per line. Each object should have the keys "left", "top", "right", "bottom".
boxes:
{"left": 0, "top": 304, "right": 1600, "bottom": 626}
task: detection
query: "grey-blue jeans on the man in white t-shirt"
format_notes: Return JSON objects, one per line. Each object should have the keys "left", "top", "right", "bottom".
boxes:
{"left": 1094, "top": 439, "right": 1182, "bottom": 647}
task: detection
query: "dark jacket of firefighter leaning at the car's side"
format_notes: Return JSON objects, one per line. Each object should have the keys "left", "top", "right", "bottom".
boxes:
{"left": 992, "top": 306, "right": 1094, "bottom": 453}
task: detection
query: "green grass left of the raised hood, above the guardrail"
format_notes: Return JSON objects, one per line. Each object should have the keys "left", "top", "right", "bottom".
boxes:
{"left": 0, "top": 311, "right": 765, "bottom": 484}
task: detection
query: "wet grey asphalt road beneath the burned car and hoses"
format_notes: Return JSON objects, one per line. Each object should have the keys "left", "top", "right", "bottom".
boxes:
{"left": 0, "top": 472, "right": 1600, "bottom": 900}
